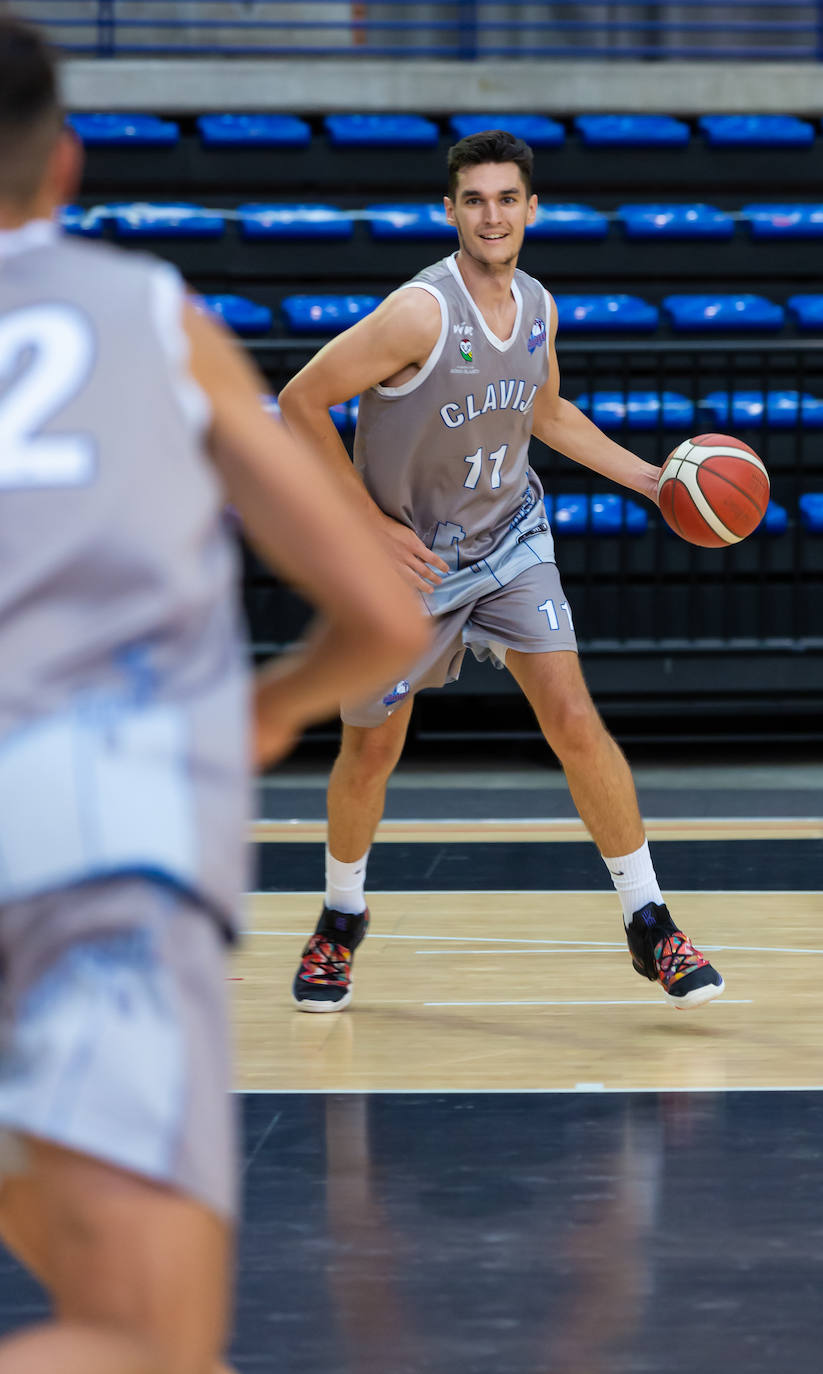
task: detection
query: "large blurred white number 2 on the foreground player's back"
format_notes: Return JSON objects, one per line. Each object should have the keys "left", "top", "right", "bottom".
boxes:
{"left": 0, "top": 305, "right": 96, "bottom": 491}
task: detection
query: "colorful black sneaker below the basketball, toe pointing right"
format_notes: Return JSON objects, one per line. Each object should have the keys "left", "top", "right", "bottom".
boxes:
{"left": 625, "top": 901, "right": 725, "bottom": 1011}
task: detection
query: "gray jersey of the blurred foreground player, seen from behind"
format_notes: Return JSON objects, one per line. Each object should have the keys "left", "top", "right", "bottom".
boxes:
{"left": 0, "top": 221, "right": 249, "bottom": 925}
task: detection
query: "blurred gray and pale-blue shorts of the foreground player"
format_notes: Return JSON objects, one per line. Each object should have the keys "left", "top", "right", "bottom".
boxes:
{"left": 0, "top": 877, "right": 238, "bottom": 1219}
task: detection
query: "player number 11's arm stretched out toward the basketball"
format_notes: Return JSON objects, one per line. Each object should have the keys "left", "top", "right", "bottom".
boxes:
{"left": 533, "top": 300, "right": 659, "bottom": 506}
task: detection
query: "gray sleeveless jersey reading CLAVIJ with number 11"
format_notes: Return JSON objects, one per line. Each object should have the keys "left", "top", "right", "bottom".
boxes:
{"left": 354, "top": 256, "right": 551, "bottom": 570}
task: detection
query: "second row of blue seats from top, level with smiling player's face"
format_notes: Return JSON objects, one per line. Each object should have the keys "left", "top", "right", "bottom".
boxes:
{"left": 62, "top": 201, "right": 823, "bottom": 242}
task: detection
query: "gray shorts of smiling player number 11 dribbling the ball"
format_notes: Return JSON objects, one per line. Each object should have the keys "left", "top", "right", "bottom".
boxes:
{"left": 341, "top": 563, "right": 577, "bottom": 727}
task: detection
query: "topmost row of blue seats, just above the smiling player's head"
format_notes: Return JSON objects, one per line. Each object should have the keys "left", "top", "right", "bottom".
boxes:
{"left": 69, "top": 113, "right": 815, "bottom": 148}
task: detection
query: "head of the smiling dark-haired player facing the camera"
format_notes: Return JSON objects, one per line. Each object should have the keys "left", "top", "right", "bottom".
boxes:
{"left": 444, "top": 129, "right": 537, "bottom": 268}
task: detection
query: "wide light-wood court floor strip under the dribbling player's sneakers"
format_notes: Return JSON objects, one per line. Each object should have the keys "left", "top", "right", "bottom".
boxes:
{"left": 232, "top": 884, "right": 823, "bottom": 1092}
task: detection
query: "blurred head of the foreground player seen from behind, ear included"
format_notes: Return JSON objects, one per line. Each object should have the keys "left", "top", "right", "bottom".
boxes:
{"left": 0, "top": 18, "right": 80, "bottom": 225}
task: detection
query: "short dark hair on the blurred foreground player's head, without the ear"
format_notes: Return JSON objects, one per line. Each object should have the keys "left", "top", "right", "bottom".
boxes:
{"left": 0, "top": 18, "right": 62, "bottom": 202}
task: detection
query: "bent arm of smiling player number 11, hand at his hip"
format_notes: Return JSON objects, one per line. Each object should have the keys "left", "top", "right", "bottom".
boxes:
{"left": 278, "top": 289, "right": 448, "bottom": 591}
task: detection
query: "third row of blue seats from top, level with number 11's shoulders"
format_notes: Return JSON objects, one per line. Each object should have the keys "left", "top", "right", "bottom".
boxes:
{"left": 202, "top": 293, "right": 823, "bottom": 334}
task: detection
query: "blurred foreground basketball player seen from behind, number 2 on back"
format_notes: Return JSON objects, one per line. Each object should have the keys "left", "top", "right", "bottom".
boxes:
{"left": 0, "top": 19, "right": 427, "bottom": 1374}
